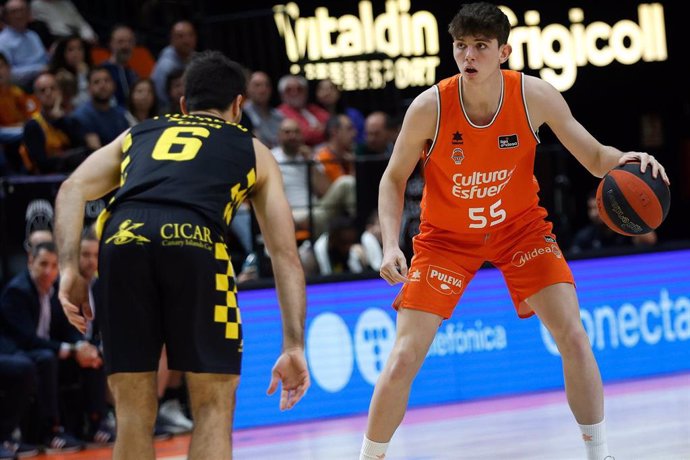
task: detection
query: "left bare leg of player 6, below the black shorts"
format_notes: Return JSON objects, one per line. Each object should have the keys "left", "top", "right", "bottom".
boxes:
{"left": 108, "top": 372, "right": 158, "bottom": 460}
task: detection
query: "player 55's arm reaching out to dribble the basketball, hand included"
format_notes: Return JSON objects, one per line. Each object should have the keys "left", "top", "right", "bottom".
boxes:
{"left": 524, "top": 76, "right": 669, "bottom": 184}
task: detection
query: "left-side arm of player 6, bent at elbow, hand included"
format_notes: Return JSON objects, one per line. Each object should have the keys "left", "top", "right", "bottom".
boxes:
{"left": 55, "top": 132, "right": 127, "bottom": 333}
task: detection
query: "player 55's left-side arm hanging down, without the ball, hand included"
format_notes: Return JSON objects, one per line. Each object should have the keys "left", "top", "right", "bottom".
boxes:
{"left": 379, "top": 88, "right": 438, "bottom": 284}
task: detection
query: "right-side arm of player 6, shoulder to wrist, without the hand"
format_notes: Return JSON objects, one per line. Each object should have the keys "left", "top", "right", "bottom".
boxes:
{"left": 251, "top": 140, "right": 306, "bottom": 350}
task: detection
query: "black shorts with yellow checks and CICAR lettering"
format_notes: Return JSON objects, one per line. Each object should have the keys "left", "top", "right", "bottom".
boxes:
{"left": 96, "top": 205, "right": 242, "bottom": 374}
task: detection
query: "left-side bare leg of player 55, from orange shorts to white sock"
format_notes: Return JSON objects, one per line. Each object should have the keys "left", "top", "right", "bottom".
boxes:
{"left": 366, "top": 309, "right": 441, "bottom": 442}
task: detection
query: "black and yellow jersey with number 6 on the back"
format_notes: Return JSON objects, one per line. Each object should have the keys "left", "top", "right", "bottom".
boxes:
{"left": 102, "top": 115, "right": 256, "bottom": 234}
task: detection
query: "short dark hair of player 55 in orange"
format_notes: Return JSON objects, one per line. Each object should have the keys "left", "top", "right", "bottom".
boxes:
{"left": 448, "top": 2, "right": 510, "bottom": 45}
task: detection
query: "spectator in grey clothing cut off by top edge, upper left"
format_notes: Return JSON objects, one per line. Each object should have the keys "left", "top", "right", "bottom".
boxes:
{"left": 31, "top": 0, "right": 98, "bottom": 44}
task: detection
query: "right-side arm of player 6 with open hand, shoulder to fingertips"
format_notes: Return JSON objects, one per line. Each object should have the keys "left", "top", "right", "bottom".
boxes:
{"left": 252, "top": 140, "right": 310, "bottom": 410}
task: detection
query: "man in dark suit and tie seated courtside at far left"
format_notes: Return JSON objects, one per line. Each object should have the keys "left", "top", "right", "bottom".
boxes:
{"left": 0, "top": 242, "right": 88, "bottom": 453}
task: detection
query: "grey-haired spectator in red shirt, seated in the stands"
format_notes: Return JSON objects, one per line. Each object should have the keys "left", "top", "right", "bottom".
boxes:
{"left": 278, "top": 75, "right": 330, "bottom": 147}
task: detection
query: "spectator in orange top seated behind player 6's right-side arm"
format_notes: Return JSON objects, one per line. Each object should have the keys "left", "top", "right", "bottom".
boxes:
{"left": 314, "top": 114, "right": 356, "bottom": 183}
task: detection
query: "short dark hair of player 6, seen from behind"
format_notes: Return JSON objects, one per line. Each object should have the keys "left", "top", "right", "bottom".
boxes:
{"left": 184, "top": 51, "right": 246, "bottom": 112}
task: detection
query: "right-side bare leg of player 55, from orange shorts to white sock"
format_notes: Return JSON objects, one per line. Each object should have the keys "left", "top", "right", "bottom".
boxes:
{"left": 527, "top": 283, "right": 604, "bottom": 425}
